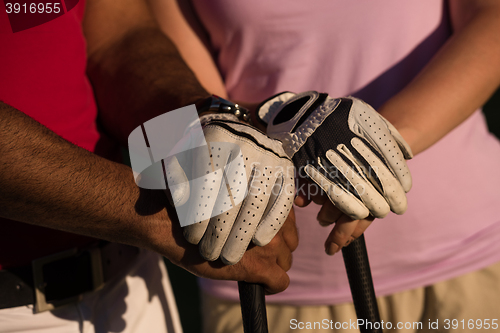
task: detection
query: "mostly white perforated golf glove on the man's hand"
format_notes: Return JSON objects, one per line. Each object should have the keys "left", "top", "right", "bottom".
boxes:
{"left": 165, "top": 114, "right": 295, "bottom": 265}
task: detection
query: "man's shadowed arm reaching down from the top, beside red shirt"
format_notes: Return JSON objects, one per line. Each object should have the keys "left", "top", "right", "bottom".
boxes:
{"left": 83, "top": 0, "right": 209, "bottom": 144}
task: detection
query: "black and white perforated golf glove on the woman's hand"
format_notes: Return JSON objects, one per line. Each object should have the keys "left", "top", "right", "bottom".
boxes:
{"left": 257, "top": 91, "right": 412, "bottom": 219}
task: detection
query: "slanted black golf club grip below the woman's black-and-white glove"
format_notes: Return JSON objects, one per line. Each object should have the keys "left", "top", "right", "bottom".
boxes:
{"left": 342, "top": 235, "right": 382, "bottom": 333}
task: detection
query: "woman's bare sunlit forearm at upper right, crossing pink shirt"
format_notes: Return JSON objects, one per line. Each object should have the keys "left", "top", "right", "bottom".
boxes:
{"left": 379, "top": 0, "right": 500, "bottom": 154}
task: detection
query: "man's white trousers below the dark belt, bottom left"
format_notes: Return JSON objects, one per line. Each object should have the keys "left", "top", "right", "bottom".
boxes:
{"left": 0, "top": 251, "right": 182, "bottom": 333}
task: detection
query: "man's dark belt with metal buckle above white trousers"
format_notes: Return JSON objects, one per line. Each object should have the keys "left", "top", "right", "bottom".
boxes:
{"left": 0, "top": 242, "right": 140, "bottom": 313}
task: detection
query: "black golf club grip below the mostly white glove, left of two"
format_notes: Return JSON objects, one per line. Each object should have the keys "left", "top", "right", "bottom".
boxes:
{"left": 238, "top": 281, "right": 268, "bottom": 333}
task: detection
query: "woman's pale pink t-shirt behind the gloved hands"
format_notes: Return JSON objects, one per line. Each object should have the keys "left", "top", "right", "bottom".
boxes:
{"left": 193, "top": 0, "right": 500, "bottom": 304}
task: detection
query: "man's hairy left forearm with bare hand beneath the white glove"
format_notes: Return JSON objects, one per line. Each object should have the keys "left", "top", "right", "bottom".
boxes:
{"left": 0, "top": 102, "right": 297, "bottom": 293}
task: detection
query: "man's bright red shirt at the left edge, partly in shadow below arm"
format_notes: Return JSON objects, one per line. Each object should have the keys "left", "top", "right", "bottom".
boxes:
{"left": 0, "top": 0, "right": 106, "bottom": 269}
